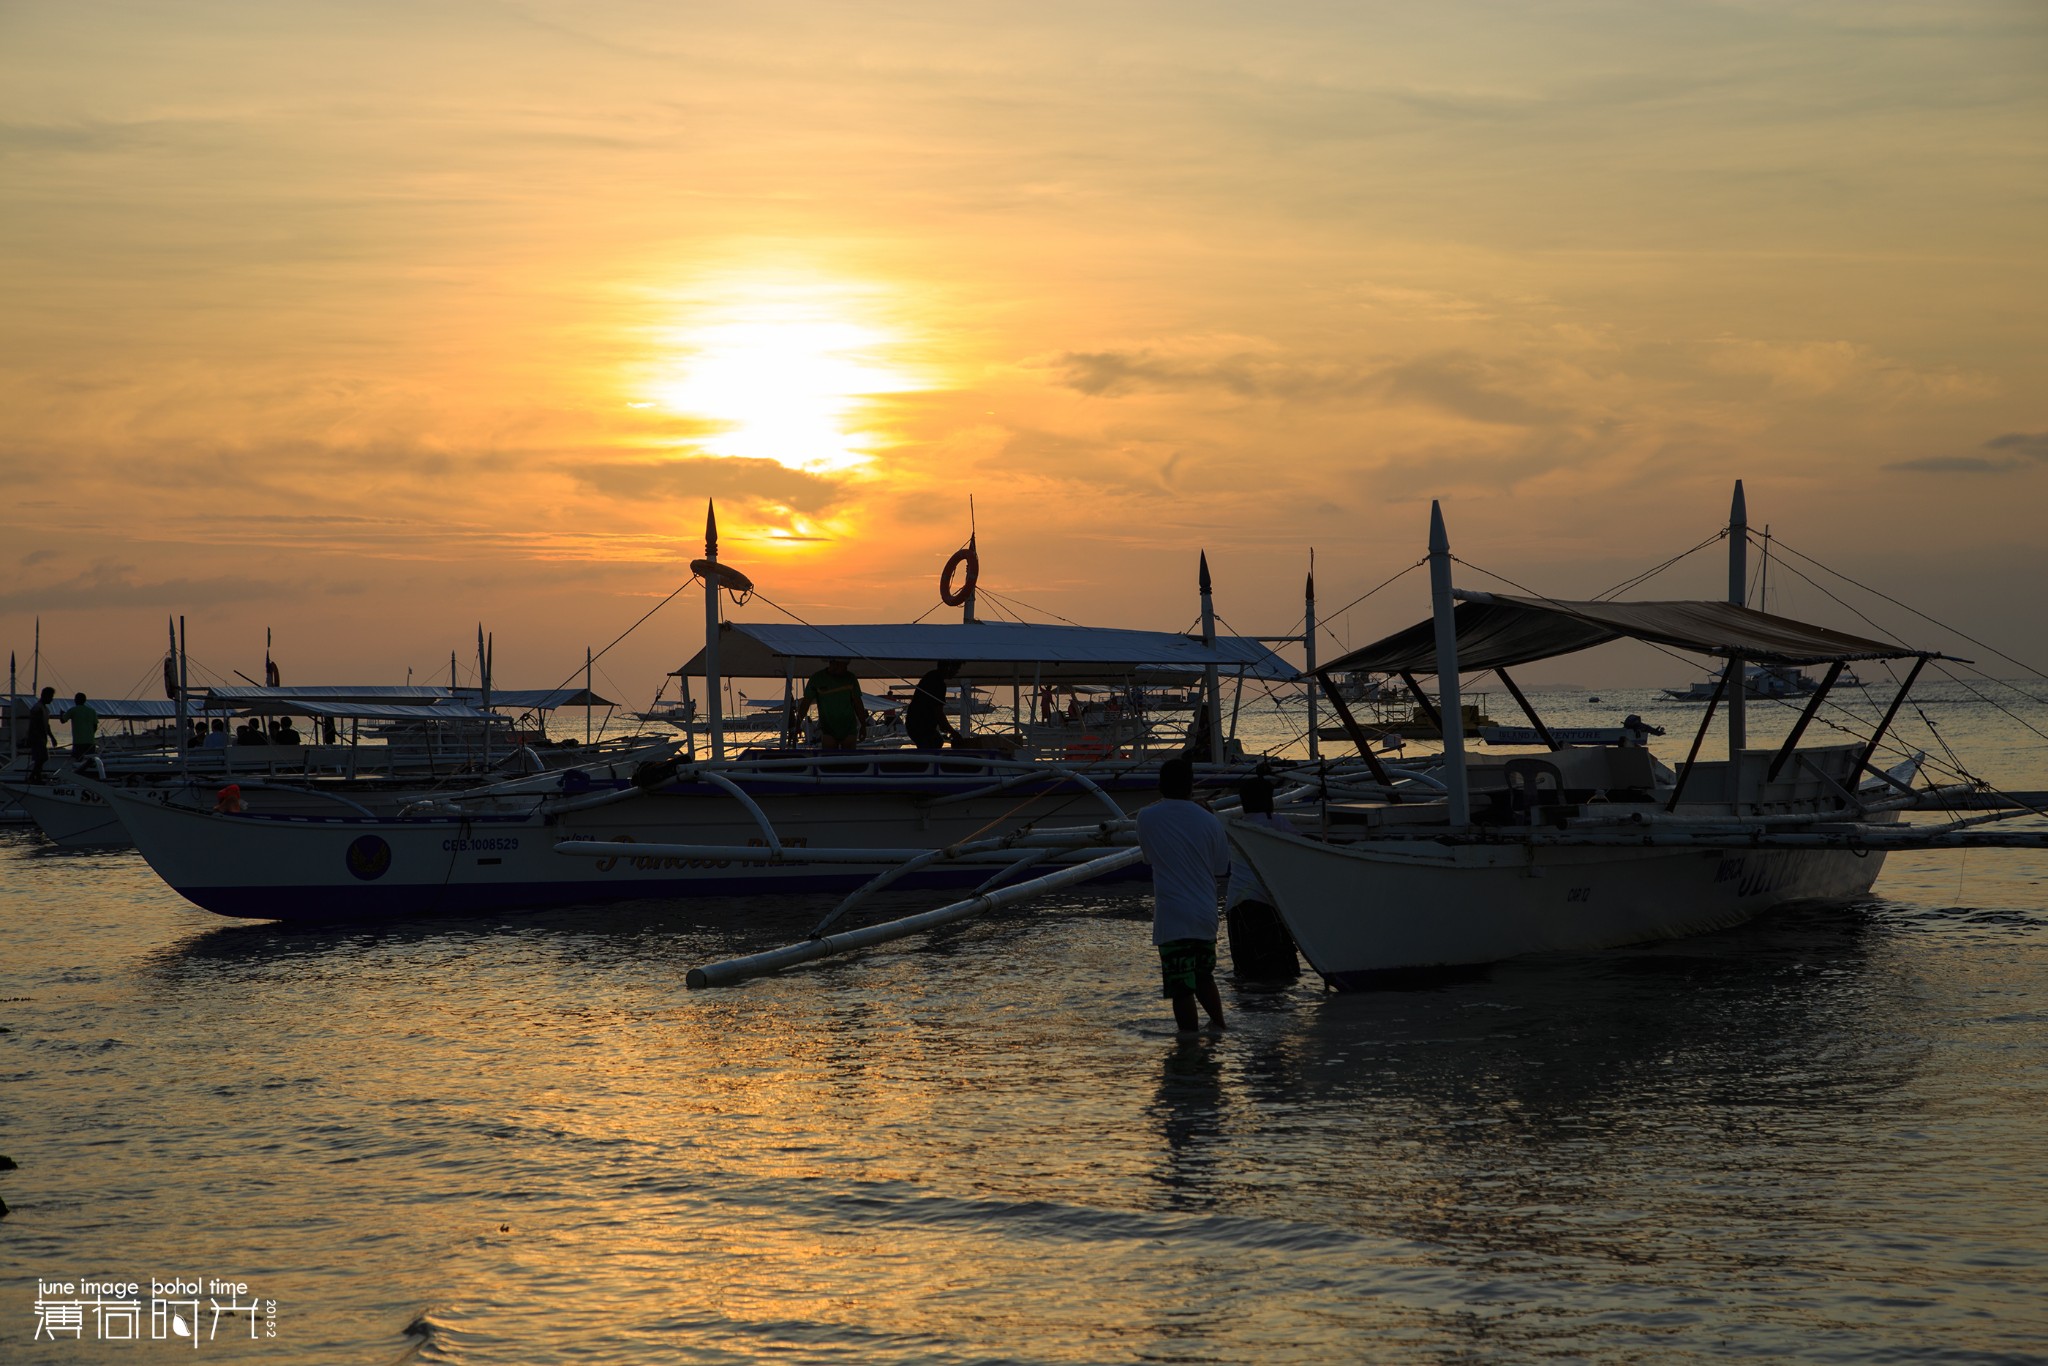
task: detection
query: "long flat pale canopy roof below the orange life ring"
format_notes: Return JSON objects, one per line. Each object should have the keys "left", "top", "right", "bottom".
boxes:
{"left": 674, "top": 621, "right": 1294, "bottom": 682}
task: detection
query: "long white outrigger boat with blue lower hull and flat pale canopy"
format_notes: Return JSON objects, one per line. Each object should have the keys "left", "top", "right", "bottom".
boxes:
{"left": 96, "top": 507, "right": 1296, "bottom": 920}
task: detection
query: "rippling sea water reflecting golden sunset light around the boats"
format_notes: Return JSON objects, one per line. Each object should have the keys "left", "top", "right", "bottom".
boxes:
{"left": 0, "top": 688, "right": 2048, "bottom": 1362}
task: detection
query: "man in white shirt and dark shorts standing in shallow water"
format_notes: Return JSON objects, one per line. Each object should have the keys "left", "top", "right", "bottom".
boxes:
{"left": 1139, "top": 758, "right": 1231, "bottom": 1034}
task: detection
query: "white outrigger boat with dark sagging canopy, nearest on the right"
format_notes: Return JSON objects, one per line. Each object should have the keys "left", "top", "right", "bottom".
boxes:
{"left": 1229, "top": 483, "right": 2048, "bottom": 987}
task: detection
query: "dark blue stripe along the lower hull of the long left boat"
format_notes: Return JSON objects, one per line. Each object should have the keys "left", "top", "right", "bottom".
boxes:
{"left": 178, "top": 864, "right": 1151, "bottom": 924}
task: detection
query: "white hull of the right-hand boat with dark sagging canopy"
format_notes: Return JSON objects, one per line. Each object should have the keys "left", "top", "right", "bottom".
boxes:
{"left": 1231, "top": 825, "right": 1884, "bottom": 989}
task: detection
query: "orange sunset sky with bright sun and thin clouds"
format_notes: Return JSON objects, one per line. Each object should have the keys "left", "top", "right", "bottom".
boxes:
{"left": 0, "top": 0, "right": 2048, "bottom": 702}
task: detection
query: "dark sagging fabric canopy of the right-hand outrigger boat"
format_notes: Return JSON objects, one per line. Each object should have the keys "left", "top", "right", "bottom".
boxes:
{"left": 1317, "top": 592, "right": 1942, "bottom": 674}
